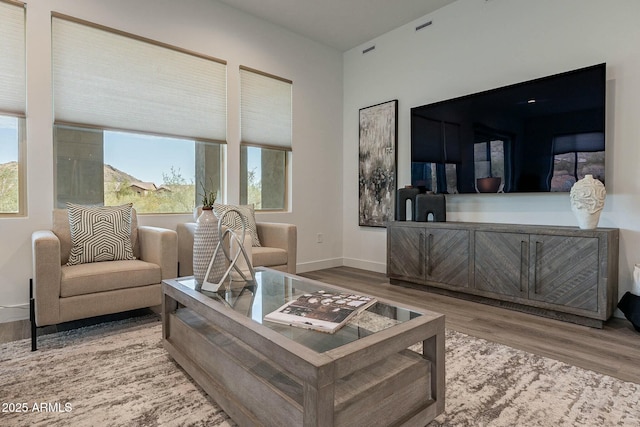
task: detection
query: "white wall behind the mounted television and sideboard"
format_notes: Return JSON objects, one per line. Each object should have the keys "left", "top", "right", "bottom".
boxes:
{"left": 343, "top": 0, "right": 640, "bottom": 310}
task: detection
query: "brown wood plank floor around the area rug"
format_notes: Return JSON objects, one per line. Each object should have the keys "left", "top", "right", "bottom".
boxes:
{"left": 5, "top": 267, "right": 640, "bottom": 384}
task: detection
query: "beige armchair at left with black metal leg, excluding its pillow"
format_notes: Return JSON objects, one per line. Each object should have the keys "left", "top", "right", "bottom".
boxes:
{"left": 31, "top": 209, "right": 178, "bottom": 350}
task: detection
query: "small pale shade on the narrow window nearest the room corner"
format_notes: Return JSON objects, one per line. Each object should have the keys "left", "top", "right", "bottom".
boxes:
{"left": 240, "top": 67, "right": 292, "bottom": 150}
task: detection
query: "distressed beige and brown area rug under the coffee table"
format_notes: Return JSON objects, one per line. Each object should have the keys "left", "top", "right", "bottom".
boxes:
{"left": 0, "top": 316, "right": 640, "bottom": 427}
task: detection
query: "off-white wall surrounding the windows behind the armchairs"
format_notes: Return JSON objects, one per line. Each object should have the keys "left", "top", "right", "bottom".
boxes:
{"left": 0, "top": 0, "right": 342, "bottom": 322}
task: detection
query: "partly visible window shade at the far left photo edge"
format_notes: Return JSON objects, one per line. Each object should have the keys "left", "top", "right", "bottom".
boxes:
{"left": 0, "top": 1, "right": 26, "bottom": 117}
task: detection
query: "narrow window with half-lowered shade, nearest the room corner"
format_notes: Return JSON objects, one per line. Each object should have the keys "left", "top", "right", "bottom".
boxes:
{"left": 240, "top": 67, "right": 292, "bottom": 210}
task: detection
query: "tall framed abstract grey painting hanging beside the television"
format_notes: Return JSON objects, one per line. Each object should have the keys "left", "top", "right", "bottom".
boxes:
{"left": 358, "top": 99, "right": 398, "bottom": 227}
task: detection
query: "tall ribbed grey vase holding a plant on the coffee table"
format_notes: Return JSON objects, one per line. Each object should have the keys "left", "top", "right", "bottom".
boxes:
{"left": 193, "top": 207, "right": 225, "bottom": 289}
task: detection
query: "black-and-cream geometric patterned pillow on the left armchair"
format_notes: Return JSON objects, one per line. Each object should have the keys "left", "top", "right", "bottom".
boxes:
{"left": 67, "top": 203, "right": 136, "bottom": 265}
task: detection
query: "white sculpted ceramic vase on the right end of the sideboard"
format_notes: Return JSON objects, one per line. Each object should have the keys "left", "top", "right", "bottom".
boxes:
{"left": 569, "top": 175, "right": 607, "bottom": 230}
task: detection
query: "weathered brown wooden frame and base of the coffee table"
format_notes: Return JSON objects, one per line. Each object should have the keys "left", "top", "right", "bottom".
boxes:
{"left": 163, "top": 276, "right": 444, "bottom": 426}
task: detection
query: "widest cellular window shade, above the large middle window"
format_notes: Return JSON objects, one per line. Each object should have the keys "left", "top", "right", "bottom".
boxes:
{"left": 52, "top": 15, "right": 227, "bottom": 142}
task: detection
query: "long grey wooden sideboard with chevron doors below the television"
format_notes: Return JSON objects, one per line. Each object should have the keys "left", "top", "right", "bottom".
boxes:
{"left": 387, "top": 221, "right": 619, "bottom": 328}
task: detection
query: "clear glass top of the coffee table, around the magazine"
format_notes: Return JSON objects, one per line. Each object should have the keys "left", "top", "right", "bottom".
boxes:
{"left": 176, "top": 268, "right": 422, "bottom": 353}
